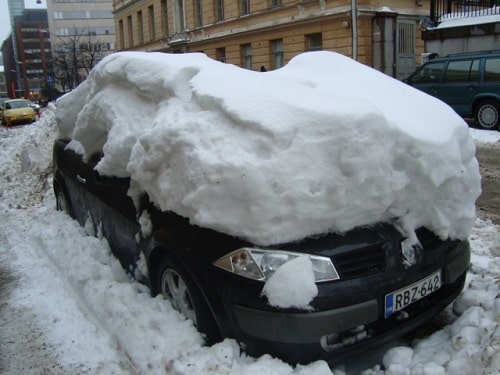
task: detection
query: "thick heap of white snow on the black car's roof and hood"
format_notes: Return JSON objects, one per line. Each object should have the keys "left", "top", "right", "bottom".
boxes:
{"left": 56, "top": 52, "right": 480, "bottom": 245}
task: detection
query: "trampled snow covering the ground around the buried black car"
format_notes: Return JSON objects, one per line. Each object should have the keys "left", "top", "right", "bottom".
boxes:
{"left": 0, "top": 119, "right": 500, "bottom": 375}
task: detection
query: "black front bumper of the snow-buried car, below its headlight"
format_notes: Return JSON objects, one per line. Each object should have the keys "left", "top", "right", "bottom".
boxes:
{"left": 220, "top": 242, "right": 470, "bottom": 363}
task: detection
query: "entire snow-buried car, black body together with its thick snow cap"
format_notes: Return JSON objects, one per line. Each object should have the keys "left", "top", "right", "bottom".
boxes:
{"left": 53, "top": 52, "right": 480, "bottom": 363}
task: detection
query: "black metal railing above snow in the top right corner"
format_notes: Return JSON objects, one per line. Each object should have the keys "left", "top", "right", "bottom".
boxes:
{"left": 431, "top": 0, "right": 500, "bottom": 25}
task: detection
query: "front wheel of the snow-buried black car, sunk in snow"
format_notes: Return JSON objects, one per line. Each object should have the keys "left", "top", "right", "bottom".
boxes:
{"left": 157, "top": 255, "right": 220, "bottom": 345}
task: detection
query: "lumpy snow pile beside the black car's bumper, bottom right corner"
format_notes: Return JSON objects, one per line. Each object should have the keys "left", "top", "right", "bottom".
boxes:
{"left": 363, "top": 219, "right": 500, "bottom": 375}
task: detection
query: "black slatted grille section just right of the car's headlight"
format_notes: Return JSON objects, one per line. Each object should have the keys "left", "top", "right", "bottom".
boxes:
{"left": 333, "top": 244, "right": 386, "bottom": 279}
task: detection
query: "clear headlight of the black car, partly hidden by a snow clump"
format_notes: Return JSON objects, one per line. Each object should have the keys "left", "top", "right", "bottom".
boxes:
{"left": 213, "top": 247, "right": 340, "bottom": 282}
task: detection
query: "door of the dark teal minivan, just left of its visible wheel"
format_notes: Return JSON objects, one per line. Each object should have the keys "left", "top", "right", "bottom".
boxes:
{"left": 442, "top": 58, "right": 481, "bottom": 116}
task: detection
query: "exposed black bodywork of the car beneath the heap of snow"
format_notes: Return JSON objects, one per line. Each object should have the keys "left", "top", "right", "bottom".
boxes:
{"left": 53, "top": 140, "right": 470, "bottom": 363}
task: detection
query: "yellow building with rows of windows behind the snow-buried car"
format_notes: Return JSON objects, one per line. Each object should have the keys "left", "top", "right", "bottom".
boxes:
{"left": 113, "top": 0, "right": 429, "bottom": 78}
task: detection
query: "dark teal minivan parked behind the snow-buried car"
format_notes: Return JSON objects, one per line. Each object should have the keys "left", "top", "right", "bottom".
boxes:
{"left": 404, "top": 51, "right": 500, "bottom": 129}
